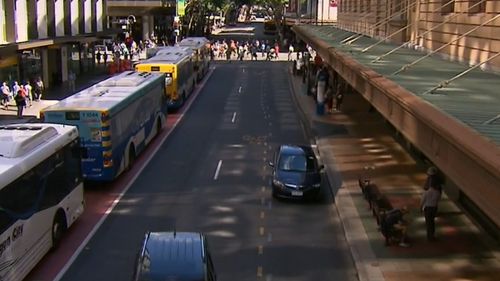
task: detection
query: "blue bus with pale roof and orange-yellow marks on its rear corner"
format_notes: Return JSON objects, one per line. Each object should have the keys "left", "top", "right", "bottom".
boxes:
{"left": 41, "top": 71, "right": 167, "bottom": 181}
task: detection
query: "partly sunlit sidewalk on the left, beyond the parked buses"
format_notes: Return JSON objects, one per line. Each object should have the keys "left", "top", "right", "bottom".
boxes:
{"left": 0, "top": 67, "right": 110, "bottom": 125}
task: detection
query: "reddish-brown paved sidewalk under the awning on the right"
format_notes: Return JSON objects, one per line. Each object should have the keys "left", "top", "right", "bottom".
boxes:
{"left": 290, "top": 65, "right": 500, "bottom": 281}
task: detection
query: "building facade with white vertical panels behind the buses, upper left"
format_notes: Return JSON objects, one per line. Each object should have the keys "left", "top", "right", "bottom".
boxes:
{"left": 0, "top": 0, "right": 113, "bottom": 87}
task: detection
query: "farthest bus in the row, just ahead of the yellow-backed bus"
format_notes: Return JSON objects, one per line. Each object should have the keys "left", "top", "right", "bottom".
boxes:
{"left": 178, "top": 37, "right": 210, "bottom": 81}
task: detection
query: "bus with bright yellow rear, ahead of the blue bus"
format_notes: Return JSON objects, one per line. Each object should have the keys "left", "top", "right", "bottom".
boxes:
{"left": 135, "top": 51, "right": 196, "bottom": 110}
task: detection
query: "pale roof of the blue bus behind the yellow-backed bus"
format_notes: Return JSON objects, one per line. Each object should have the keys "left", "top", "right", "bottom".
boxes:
{"left": 42, "top": 71, "right": 164, "bottom": 113}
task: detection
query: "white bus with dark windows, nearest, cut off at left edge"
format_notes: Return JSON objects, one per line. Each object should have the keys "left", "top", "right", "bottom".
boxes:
{"left": 0, "top": 123, "right": 84, "bottom": 281}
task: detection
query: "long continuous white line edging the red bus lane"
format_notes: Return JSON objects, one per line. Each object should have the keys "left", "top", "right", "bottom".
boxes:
{"left": 54, "top": 67, "right": 215, "bottom": 281}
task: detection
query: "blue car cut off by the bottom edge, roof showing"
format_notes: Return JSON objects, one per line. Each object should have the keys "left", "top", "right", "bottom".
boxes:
{"left": 132, "top": 231, "right": 217, "bottom": 281}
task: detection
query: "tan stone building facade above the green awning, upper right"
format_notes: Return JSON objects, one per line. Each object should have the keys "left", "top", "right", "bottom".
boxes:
{"left": 338, "top": 0, "right": 500, "bottom": 71}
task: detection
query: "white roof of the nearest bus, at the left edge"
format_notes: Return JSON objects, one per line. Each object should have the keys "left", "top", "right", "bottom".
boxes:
{"left": 0, "top": 123, "right": 78, "bottom": 188}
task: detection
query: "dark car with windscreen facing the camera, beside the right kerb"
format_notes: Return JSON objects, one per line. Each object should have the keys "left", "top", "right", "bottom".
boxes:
{"left": 269, "top": 145, "right": 324, "bottom": 199}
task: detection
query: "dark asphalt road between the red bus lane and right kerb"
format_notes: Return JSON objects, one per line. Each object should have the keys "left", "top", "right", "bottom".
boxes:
{"left": 62, "top": 62, "right": 357, "bottom": 281}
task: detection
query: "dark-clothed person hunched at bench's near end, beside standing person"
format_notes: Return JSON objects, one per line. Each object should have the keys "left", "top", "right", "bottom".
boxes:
{"left": 380, "top": 206, "right": 410, "bottom": 247}
